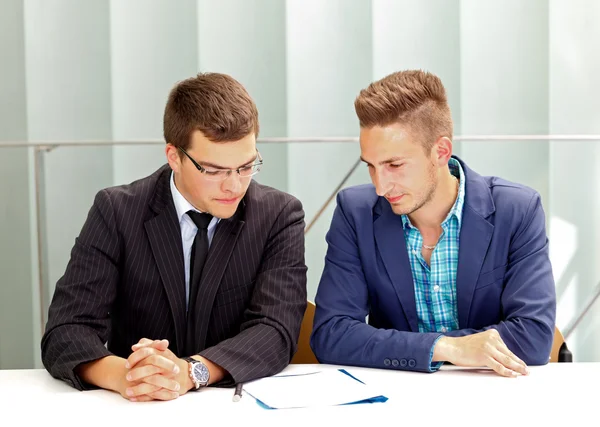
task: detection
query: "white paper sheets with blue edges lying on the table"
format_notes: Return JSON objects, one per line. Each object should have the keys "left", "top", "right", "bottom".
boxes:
{"left": 244, "top": 369, "right": 387, "bottom": 409}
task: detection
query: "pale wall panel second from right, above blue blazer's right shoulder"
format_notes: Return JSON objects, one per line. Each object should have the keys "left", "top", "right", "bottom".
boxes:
{"left": 460, "top": 0, "right": 549, "bottom": 211}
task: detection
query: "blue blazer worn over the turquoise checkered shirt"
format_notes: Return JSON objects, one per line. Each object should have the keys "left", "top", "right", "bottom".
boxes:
{"left": 311, "top": 157, "right": 556, "bottom": 372}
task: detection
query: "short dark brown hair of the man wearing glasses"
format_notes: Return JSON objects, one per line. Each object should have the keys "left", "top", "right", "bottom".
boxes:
{"left": 163, "top": 73, "right": 259, "bottom": 149}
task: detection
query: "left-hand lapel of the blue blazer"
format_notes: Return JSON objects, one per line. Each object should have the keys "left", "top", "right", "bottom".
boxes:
{"left": 373, "top": 199, "right": 419, "bottom": 332}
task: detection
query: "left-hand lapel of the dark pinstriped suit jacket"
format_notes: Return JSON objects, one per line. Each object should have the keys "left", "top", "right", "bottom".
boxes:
{"left": 145, "top": 169, "right": 186, "bottom": 356}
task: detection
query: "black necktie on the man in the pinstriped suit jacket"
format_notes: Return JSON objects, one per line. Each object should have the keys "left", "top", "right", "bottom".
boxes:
{"left": 185, "top": 211, "right": 213, "bottom": 356}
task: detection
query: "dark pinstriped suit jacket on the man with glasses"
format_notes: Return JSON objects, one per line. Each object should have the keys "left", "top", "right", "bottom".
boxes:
{"left": 42, "top": 165, "right": 307, "bottom": 390}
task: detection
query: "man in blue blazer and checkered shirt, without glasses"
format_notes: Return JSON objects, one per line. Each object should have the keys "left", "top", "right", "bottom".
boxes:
{"left": 311, "top": 71, "right": 556, "bottom": 376}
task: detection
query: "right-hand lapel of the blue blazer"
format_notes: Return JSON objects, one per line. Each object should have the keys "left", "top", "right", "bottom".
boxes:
{"left": 456, "top": 159, "right": 495, "bottom": 329}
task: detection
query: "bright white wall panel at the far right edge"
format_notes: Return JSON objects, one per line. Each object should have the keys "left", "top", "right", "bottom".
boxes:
{"left": 548, "top": 0, "right": 600, "bottom": 361}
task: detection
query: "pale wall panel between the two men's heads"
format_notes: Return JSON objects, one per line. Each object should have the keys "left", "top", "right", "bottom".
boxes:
{"left": 287, "top": 0, "right": 372, "bottom": 300}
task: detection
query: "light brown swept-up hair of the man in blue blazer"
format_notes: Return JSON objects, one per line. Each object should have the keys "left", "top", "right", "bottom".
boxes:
{"left": 354, "top": 70, "right": 453, "bottom": 153}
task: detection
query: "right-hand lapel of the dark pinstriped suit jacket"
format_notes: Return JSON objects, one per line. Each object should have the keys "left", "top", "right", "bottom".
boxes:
{"left": 194, "top": 201, "right": 245, "bottom": 351}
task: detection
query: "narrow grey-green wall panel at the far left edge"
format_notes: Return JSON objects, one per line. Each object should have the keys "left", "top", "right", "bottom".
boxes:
{"left": 0, "top": 0, "right": 34, "bottom": 369}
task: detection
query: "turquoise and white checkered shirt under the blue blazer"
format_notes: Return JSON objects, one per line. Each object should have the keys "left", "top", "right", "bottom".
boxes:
{"left": 402, "top": 158, "right": 465, "bottom": 370}
